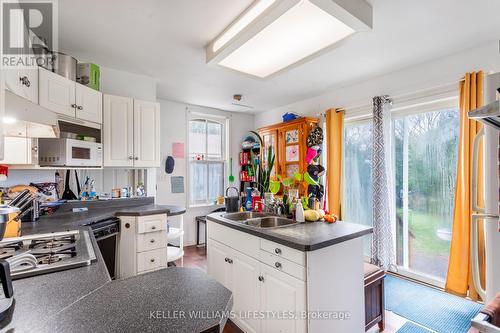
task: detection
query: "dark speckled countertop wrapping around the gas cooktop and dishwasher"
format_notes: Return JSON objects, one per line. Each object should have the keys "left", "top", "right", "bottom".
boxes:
{"left": 0, "top": 198, "right": 232, "bottom": 332}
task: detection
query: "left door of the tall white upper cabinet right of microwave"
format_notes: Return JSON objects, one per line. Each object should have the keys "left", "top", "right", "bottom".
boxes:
{"left": 102, "top": 95, "right": 134, "bottom": 166}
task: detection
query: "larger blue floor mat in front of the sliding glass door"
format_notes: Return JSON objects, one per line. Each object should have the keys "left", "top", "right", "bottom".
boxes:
{"left": 385, "top": 275, "right": 482, "bottom": 333}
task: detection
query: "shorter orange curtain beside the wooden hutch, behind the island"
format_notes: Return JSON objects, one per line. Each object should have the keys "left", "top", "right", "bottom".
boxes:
{"left": 326, "top": 109, "right": 344, "bottom": 218}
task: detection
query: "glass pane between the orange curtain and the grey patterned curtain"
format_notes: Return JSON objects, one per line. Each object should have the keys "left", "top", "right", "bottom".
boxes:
{"left": 342, "top": 120, "right": 373, "bottom": 256}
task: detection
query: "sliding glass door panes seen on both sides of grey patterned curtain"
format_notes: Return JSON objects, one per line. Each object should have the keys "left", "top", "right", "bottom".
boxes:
{"left": 342, "top": 106, "right": 459, "bottom": 286}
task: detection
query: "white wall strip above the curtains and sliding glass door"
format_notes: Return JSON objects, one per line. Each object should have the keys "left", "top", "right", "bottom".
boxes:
{"left": 255, "top": 42, "right": 500, "bottom": 127}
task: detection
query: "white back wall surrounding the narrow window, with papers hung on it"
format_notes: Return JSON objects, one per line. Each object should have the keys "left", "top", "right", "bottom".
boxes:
{"left": 156, "top": 100, "right": 255, "bottom": 245}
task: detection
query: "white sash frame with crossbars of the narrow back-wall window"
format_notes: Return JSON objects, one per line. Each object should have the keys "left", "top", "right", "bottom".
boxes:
{"left": 186, "top": 112, "right": 229, "bottom": 208}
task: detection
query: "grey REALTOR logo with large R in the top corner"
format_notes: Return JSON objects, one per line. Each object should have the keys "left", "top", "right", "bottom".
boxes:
{"left": 0, "top": 0, "right": 57, "bottom": 67}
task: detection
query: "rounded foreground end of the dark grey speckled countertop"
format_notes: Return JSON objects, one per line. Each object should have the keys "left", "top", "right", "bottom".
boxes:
{"left": 37, "top": 267, "right": 232, "bottom": 332}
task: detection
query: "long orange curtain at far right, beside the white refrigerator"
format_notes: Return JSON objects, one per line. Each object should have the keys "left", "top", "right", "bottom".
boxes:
{"left": 445, "top": 72, "right": 485, "bottom": 300}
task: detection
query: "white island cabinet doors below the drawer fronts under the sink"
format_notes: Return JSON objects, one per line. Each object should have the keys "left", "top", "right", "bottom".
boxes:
{"left": 208, "top": 236, "right": 307, "bottom": 333}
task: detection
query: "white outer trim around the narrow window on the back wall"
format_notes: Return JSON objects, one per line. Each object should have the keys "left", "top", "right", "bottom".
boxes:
{"left": 185, "top": 107, "right": 231, "bottom": 208}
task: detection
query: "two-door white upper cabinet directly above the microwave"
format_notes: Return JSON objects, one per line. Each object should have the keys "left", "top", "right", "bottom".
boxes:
{"left": 38, "top": 68, "right": 102, "bottom": 123}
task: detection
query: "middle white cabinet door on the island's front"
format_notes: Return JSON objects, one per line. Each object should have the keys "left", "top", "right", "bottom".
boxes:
{"left": 230, "top": 251, "right": 261, "bottom": 333}
